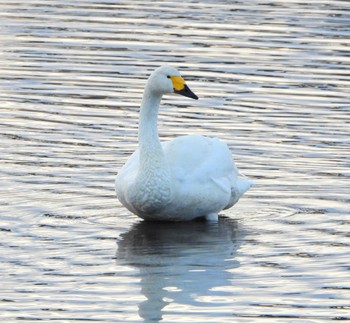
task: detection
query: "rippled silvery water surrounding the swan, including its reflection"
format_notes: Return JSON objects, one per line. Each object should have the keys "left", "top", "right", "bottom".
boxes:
{"left": 0, "top": 0, "right": 350, "bottom": 323}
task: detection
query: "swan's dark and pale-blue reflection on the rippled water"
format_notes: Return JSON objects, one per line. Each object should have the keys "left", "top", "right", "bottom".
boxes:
{"left": 117, "top": 218, "right": 239, "bottom": 322}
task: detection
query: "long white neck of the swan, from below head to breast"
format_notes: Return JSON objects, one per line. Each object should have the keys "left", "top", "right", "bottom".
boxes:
{"left": 134, "top": 86, "right": 171, "bottom": 213}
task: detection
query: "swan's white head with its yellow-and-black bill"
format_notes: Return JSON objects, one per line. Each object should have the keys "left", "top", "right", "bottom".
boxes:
{"left": 147, "top": 66, "right": 198, "bottom": 100}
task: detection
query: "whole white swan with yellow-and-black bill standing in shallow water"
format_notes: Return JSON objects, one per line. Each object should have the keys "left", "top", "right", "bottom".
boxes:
{"left": 115, "top": 66, "right": 253, "bottom": 221}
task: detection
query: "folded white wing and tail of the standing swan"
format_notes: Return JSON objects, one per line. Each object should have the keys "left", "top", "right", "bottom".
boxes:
{"left": 163, "top": 136, "right": 253, "bottom": 209}
